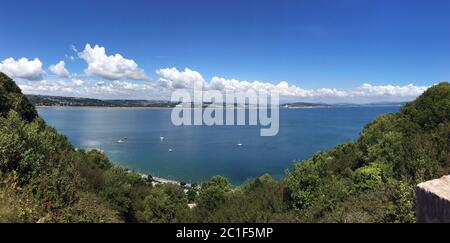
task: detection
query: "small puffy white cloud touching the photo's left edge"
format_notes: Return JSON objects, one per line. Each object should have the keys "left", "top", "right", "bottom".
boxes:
{"left": 0, "top": 58, "right": 45, "bottom": 81}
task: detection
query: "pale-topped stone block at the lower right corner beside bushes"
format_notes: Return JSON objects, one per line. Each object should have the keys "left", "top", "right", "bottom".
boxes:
{"left": 416, "top": 176, "right": 450, "bottom": 223}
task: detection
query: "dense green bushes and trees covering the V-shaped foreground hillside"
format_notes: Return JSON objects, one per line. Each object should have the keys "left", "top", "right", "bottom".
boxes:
{"left": 0, "top": 73, "right": 450, "bottom": 223}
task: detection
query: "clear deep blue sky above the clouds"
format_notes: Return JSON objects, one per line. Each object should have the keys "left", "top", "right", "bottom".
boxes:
{"left": 0, "top": 0, "right": 450, "bottom": 101}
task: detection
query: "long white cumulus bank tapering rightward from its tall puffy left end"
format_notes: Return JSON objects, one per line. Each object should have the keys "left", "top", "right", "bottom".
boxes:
{"left": 156, "top": 68, "right": 428, "bottom": 100}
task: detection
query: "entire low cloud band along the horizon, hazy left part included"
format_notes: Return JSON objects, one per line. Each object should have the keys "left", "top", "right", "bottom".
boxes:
{"left": 14, "top": 62, "right": 428, "bottom": 103}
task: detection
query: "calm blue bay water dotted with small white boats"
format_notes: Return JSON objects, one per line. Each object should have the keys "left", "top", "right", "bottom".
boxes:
{"left": 39, "top": 107, "right": 399, "bottom": 184}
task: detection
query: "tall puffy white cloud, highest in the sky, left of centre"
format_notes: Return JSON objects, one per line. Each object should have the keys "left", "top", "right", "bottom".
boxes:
{"left": 78, "top": 44, "right": 149, "bottom": 80}
